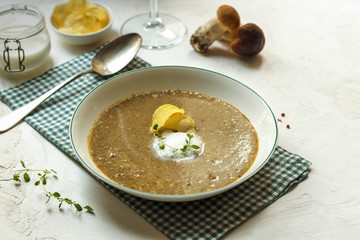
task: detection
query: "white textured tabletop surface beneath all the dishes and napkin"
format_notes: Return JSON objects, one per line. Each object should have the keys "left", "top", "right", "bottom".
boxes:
{"left": 0, "top": 0, "right": 360, "bottom": 239}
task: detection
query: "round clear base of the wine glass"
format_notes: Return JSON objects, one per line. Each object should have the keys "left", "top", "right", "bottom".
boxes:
{"left": 120, "top": 14, "right": 186, "bottom": 49}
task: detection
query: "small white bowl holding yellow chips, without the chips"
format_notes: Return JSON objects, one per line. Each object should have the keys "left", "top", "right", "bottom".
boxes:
{"left": 50, "top": 3, "right": 114, "bottom": 45}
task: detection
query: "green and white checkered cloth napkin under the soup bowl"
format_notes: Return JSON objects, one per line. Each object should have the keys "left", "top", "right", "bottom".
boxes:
{"left": 0, "top": 47, "right": 311, "bottom": 239}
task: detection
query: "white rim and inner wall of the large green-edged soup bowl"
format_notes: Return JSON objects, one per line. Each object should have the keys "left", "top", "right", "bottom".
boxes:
{"left": 70, "top": 66, "right": 278, "bottom": 202}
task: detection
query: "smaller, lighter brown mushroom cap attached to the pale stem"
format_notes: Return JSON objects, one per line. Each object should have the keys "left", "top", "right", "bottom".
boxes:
{"left": 216, "top": 5, "right": 240, "bottom": 32}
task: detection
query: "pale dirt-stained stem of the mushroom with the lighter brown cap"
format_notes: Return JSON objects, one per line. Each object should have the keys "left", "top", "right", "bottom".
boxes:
{"left": 190, "top": 17, "right": 227, "bottom": 53}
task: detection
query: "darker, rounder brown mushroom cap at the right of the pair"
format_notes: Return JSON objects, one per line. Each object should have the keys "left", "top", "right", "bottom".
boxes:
{"left": 230, "top": 23, "right": 265, "bottom": 56}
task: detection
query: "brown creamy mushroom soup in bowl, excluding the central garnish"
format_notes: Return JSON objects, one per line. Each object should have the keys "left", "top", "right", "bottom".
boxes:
{"left": 88, "top": 90, "right": 258, "bottom": 194}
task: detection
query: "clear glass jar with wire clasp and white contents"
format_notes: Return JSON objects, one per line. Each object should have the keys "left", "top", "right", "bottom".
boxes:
{"left": 0, "top": 4, "right": 51, "bottom": 72}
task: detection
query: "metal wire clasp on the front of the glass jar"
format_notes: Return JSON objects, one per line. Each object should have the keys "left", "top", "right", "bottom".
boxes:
{"left": 3, "top": 39, "right": 25, "bottom": 72}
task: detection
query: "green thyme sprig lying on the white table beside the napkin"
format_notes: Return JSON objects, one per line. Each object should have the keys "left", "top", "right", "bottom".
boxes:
{"left": 13, "top": 161, "right": 94, "bottom": 213}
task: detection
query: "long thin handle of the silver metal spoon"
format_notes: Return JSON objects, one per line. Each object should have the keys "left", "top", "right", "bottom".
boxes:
{"left": 0, "top": 69, "right": 93, "bottom": 133}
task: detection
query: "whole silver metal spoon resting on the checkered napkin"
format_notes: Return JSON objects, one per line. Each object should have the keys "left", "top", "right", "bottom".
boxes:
{"left": 0, "top": 33, "right": 142, "bottom": 133}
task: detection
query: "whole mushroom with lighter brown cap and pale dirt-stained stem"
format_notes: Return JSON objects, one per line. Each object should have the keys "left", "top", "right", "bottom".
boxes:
{"left": 190, "top": 5, "right": 240, "bottom": 53}
